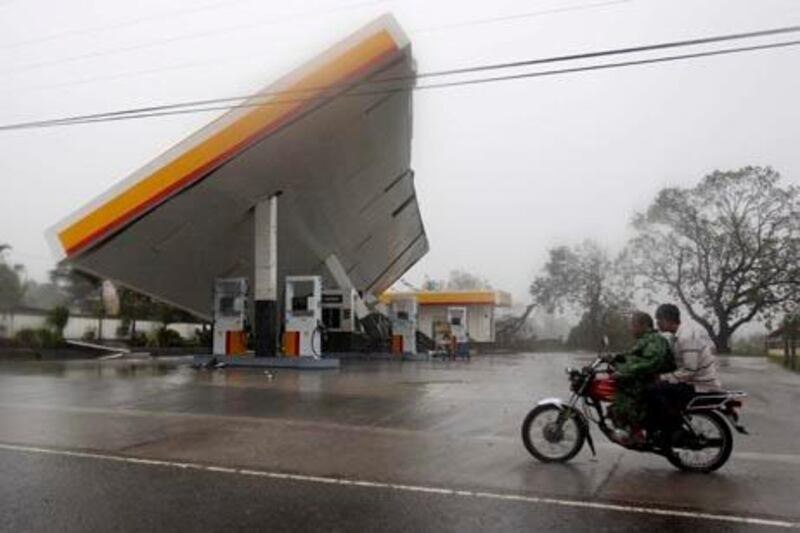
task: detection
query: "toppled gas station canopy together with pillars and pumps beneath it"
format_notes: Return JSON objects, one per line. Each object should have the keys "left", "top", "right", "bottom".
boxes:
{"left": 48, "top": 16, "right": 438, "bottom": 361}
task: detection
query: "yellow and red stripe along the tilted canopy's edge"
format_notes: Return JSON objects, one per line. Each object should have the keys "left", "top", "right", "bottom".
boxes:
{"left": 57, "top": 29, "right": 398, "bottom": 256}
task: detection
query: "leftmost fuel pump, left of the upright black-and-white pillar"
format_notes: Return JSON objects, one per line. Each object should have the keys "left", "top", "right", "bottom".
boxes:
{"left": 213, "top": 278, "right": 247, "bottom": 355}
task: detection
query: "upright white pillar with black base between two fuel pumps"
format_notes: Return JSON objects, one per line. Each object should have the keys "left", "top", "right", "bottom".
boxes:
{"left": 253, "top": 193, "right": 280, "bottom": 357}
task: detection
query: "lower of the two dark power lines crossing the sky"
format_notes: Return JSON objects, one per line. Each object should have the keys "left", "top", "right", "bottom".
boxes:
{"left": 0, "top": 36, "right": 800, "bottom": 131}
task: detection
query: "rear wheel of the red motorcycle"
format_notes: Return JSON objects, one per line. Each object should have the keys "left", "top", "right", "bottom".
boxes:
{"left": 667, "top": 411, "right": 733, "bottom": 474}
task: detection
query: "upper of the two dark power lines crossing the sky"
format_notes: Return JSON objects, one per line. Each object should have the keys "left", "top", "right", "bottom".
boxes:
{"left": 0, "top": 26, "right": 800, "bottom": 130}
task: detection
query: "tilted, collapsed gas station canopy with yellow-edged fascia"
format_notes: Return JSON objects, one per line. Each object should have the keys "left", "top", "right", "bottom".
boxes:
{"left": 48, "top": 16, "right": 428, "bottom": 318}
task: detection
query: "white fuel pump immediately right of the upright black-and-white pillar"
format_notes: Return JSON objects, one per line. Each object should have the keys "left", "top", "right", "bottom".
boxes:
{"left": 283, "top": 276, "right": 323, "bottom": 358}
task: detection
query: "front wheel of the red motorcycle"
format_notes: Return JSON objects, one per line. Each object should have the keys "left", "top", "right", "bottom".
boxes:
{"left": 522, "top": 404, "right": 586, "bottom": 463}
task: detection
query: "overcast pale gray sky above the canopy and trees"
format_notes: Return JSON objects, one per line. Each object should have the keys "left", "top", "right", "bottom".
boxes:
{"left": 0, "top": 0, "right": 800, "bottom": 300}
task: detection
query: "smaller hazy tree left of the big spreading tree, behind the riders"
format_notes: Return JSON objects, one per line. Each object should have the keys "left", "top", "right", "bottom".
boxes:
{"left": 530, "top": 241, "right": 630, "bottom": 347}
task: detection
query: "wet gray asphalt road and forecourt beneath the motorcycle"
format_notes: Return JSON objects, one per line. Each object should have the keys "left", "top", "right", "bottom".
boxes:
{"left": 0, "top": 354, "right": 800, "bottom": 531}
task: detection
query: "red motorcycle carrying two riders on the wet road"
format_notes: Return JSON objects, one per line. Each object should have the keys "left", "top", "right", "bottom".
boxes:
{"left": 522, "top": 344, "right": 747, "bottom": 473}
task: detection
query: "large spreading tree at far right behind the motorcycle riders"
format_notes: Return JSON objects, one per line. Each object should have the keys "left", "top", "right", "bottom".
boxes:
{"left": 628, "top": 167, "right": 800, "bottom": 353}
